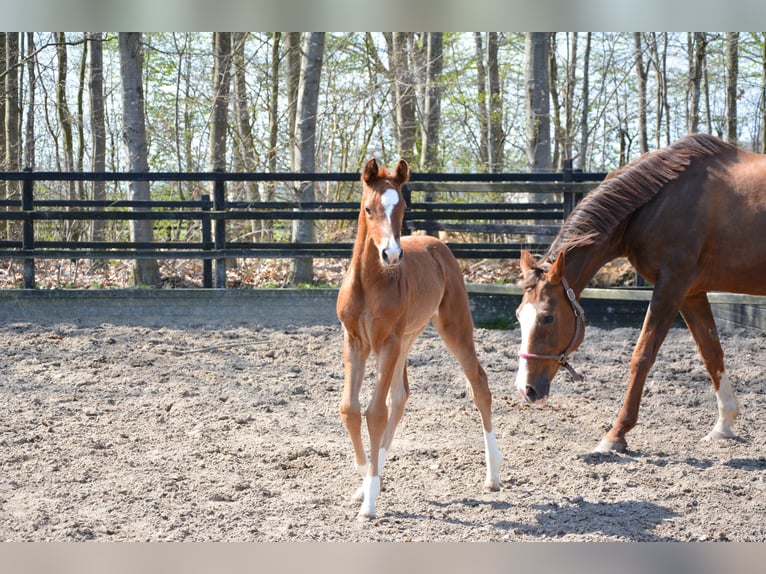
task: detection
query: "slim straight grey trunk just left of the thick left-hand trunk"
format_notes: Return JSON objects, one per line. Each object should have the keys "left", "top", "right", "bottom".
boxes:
{"left": 88, "top": 32, "right": 106, "bottom": 252}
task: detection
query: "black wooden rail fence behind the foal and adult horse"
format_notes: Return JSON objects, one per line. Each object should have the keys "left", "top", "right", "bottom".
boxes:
{"left": 0, "top": 161, "right": 605, "bottom": 288}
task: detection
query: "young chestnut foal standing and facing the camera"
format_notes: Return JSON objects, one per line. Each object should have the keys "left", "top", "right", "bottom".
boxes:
{"left": 337, "top": 159, "right": 501, "bottom": 518}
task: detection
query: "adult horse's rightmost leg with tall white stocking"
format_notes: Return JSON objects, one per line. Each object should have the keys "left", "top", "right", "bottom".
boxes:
{"left": 681, "top": 293, "right": 739, "bottom": 440}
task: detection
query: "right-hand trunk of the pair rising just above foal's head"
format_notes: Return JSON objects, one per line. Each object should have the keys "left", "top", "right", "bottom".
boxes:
{"left": 420, "top": 32, "right": 444, "bottom": 172}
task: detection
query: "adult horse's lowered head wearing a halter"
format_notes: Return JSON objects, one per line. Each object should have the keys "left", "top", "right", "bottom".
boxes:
{"left": 516, "top": 251, "right": 585, "bottom": 404}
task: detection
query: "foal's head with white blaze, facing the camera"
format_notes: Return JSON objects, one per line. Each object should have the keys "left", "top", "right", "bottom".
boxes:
{"left": 359, "top": 158, "right": 410, "bottom": 267}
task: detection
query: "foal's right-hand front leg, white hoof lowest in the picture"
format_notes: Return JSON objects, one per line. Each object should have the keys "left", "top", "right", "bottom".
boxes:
{"left": 359, "top": 335, "right": 401, "bottom": 519}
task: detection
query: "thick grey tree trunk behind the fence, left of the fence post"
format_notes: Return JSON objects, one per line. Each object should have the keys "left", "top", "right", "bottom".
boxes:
{"left": 119, "top": 32, "right": 160, "bottom": 286}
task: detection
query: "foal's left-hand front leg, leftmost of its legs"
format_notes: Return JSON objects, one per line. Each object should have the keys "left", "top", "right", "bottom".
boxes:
{"left": 340, "top": 329, "right": 370, "bottom": 486}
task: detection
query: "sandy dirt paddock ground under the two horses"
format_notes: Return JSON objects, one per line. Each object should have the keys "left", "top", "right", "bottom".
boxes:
{"left": 0, "top": 323, "right": 766, "bottom": 541}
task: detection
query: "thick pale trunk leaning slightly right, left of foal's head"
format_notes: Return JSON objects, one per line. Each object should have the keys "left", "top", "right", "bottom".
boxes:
{"left": 290, "top": 32, "right": 325, "bottom": 285}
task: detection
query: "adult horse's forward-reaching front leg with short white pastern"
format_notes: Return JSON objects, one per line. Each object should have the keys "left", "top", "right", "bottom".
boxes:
{"left": 594, "top": 285, "right": 682, "bottom": 452}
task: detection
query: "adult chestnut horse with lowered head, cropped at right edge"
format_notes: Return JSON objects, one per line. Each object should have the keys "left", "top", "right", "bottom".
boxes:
{"left": 516, "top": 134, "right": 766, "bottom": 452}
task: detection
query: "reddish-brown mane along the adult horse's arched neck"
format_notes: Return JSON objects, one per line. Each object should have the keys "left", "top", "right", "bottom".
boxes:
{"left": 543, "top": 133, "right": 736, "bottom": 262}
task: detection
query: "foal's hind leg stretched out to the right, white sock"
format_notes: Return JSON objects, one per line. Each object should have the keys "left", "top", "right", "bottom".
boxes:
{"left": 433, "top": 296, "right": 503, "bottom": 490}
